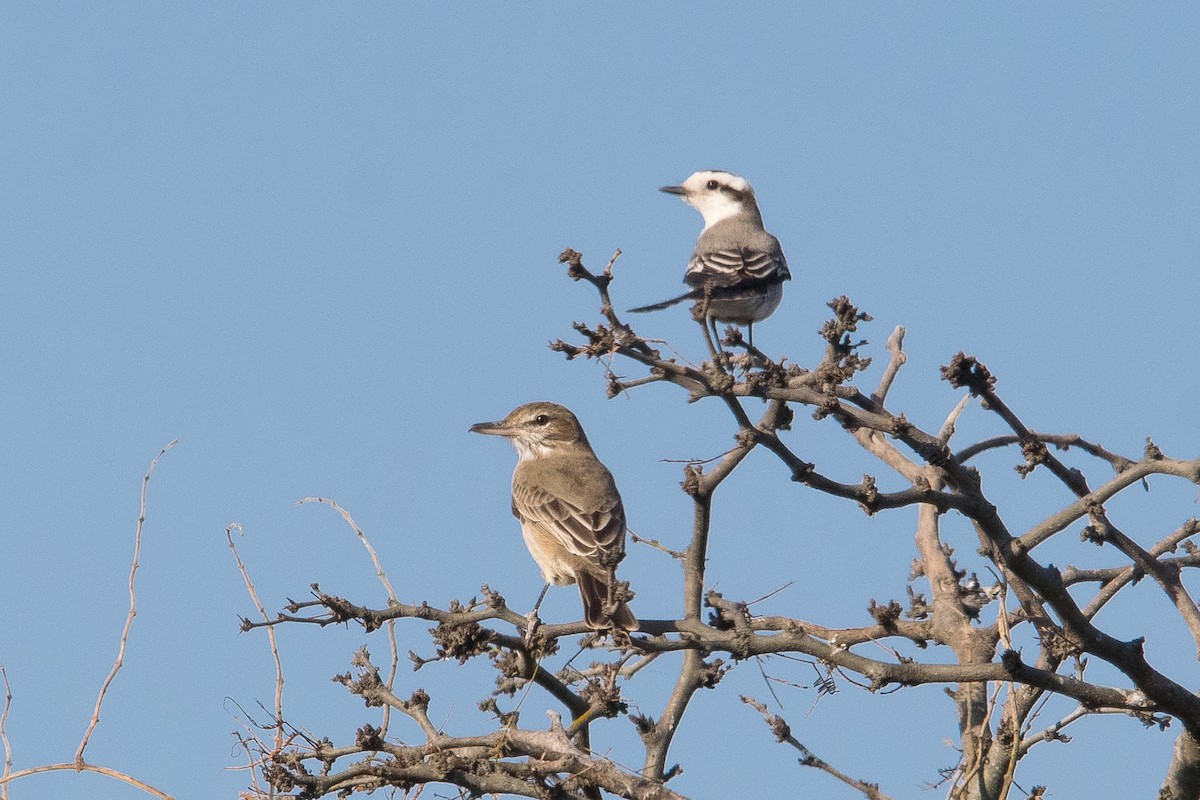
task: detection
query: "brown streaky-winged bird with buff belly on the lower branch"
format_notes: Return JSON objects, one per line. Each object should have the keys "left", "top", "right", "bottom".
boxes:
{"left": 470, "top": 402, "right": 638, "bottom": 636}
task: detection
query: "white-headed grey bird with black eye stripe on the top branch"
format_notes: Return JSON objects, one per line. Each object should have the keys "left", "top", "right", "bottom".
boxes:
{"left": 629, "top": 169, "right": 792, "bottom": 347}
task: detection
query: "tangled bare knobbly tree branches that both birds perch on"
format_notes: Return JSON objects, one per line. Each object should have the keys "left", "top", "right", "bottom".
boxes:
{"left": 231, "top": 249, "right": 1200, "bottom": 800}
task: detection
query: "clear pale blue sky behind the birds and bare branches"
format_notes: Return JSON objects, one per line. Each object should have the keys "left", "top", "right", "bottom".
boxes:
{"left": 0, "top": 4, "right": 1200, "bottom": 800}
